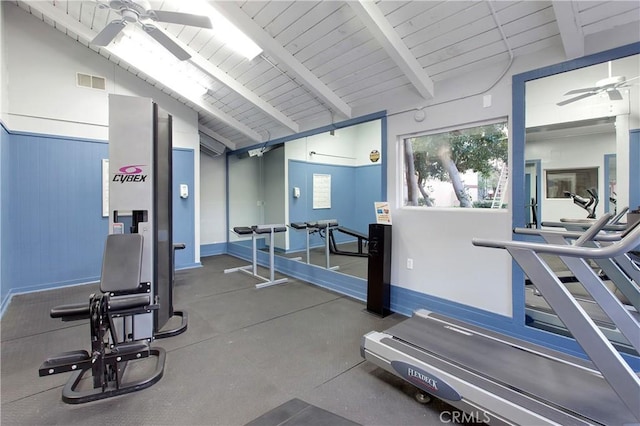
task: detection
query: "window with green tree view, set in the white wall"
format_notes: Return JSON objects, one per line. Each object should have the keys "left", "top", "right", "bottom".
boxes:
{"left": 403, "top": 122, "right": 509, "bottom": 208}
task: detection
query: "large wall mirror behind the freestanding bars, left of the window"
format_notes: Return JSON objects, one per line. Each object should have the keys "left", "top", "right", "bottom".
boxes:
{"left": 227, "top": 118, "right": 386, "bottom": 280}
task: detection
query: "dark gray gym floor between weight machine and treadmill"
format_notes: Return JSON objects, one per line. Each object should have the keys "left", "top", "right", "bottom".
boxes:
{"left": 0, "top": 255, "right": 464, "bottom": 426}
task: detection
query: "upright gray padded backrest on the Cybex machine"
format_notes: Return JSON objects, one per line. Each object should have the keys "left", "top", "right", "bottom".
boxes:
{"left": 100, "top": 234, "right": 142, "bottom": 293}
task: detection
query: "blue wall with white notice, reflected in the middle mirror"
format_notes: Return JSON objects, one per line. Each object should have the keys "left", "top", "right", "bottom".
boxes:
{"left": 288, "top": 160, "right": 381, "bottom": 251}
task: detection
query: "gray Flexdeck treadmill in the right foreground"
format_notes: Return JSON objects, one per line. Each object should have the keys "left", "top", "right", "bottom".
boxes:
{"left": 361, "top": 216, "right": 640, "bottom": 425}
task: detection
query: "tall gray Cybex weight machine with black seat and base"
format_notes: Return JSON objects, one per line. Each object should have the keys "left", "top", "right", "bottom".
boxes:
{"left": 39, "top": 95, "right": 187, "bottom": 404}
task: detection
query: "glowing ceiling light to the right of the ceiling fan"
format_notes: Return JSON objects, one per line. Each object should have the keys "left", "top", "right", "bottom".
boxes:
{"left": 175, "top": 0, "right": 262, "bottom": 60}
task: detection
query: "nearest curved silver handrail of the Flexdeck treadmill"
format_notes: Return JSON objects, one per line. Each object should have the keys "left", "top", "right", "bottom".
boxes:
{"left": 471, "top": 221, "right": 640, "bottom": 259}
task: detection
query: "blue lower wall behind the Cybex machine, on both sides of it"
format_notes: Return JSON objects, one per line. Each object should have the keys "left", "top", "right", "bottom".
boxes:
{"left": 0, "top": 128, "right": 195, "bottom": 311}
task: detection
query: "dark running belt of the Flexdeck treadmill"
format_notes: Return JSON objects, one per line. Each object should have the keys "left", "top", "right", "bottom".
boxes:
{"left": 386, "top": 316, "right": 640, "bottom": 425}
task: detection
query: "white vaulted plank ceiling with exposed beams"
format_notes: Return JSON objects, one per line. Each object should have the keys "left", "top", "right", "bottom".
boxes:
{"left": 15, "top": 0, "right": 640, "bottom": 149}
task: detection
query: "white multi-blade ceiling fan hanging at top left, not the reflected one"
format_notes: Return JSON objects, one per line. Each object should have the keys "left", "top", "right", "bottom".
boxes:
{"left": 91, "top": 0, "right": 212, "bottom": 61}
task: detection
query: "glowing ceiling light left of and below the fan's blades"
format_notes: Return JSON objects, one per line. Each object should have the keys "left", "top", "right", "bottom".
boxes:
{"left": 108, "top": 25, "right": 208, "bottom": 98}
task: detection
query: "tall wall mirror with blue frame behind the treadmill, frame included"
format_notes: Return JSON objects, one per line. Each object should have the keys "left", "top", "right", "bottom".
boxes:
{"left": 513, "top": 43, "right": 640, "bottom": 353}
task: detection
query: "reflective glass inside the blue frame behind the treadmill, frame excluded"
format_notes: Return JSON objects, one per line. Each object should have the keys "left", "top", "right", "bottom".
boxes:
{"left": 525, "top": 51, "right": 640, "bottom": 353}
